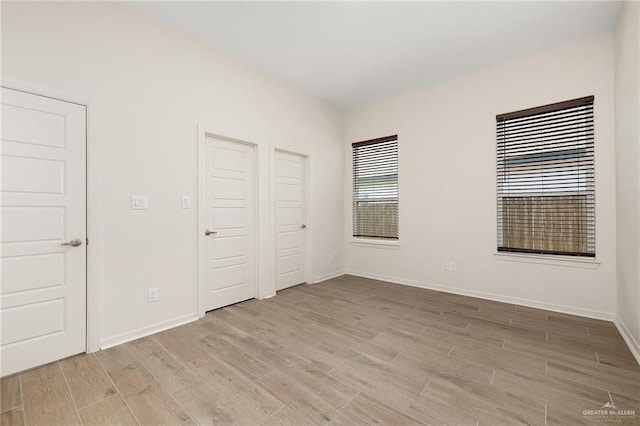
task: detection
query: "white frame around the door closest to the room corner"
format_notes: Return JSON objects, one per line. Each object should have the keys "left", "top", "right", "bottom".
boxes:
{"left": 271, "top": 147, "right": 314, "bottom": 288}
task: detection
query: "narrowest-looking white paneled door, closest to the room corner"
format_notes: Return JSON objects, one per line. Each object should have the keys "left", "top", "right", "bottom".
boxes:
{"left": 275, "top": 151, "right": 307, "bottom": 290}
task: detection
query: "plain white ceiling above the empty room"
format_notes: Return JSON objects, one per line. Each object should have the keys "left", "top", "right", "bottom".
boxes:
{"left": 135, "top": 1, "right": 621, "bottom": 108}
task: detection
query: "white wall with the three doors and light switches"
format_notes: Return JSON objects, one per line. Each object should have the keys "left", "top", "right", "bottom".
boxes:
{"left": 2, "top": 2, "right": 344, "bottom": 344}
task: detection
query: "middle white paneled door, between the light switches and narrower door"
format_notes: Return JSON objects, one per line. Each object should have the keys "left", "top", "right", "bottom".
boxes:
{"left": 203, "top": 136, "right": 256, "bottom": 311}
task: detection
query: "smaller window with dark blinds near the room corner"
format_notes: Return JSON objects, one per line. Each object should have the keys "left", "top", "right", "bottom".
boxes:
{"left": 352, "top": 135, "right": 398, "bottom": 240}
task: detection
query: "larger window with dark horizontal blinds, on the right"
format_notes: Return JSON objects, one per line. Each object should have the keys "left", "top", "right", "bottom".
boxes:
{"left": 496, "top": 96, "right": 595, "bottom": 257}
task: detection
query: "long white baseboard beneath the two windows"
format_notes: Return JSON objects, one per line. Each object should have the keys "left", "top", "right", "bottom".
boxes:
{"left": 345, "top": 270, "right": 615, "bottom": 321}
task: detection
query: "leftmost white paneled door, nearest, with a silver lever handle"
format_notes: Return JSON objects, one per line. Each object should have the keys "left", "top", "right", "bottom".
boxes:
{"left": 0, "top": 88, "right": 86, "bottom": 376}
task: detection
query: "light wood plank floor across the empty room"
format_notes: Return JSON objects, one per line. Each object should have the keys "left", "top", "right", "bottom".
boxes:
{"left": 1, "top": 276, "right": 640, "bottom": 426}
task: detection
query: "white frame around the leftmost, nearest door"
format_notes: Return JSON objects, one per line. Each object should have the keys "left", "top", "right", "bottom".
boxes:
{"left": 0, "top": 75, "right": 102, "bottom": 353}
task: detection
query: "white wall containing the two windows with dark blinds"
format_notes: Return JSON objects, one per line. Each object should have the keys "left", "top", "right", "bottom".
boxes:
{"left": 345, "top": 34, "right": 616, "bottom": 319}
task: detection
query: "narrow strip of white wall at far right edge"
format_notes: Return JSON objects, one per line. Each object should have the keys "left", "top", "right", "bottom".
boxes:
{"left": 614, "top": 1, "right": 640, "bottom": 362}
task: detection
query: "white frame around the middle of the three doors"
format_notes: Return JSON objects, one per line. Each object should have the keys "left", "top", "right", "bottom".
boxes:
{"left": 196, "top": 124, "right": 265, "bottom": 318}
